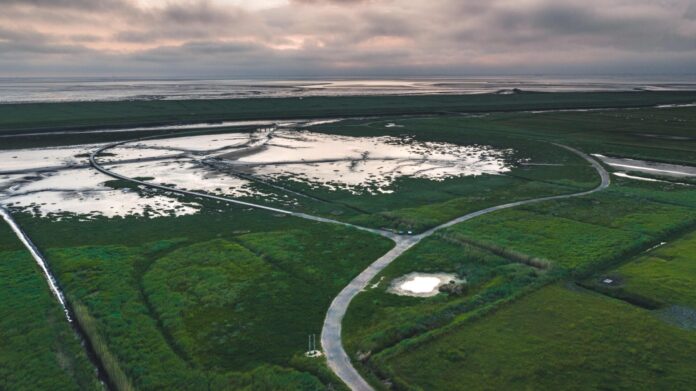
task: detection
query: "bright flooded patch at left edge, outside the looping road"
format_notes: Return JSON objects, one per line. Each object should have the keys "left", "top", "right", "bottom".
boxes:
{"left": 0, "top": 168, "right": 200, "bottom": 219}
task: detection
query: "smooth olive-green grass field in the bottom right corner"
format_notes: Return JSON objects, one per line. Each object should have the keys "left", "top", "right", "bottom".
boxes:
{"left": 378, "top": 285, "right": 696, "bottom": 390}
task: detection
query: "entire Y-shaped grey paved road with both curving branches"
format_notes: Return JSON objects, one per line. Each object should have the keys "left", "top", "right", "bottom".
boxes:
{"left": 89, "top": 135, "right": 610, "bottom": 391}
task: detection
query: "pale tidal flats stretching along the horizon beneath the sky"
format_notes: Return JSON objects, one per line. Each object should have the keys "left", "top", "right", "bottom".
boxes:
{"left": 0, "top": 76, "right": 696, "bottom": 104}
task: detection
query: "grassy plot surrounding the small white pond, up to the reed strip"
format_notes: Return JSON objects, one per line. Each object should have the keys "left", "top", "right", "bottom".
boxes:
{"left": 343, "top": 237, "right": 545, "bottom": 357}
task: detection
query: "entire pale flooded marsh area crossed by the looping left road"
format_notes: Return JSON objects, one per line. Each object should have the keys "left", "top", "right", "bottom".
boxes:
{"left": 0, "top": 120, "right": 512, "bottom": 218}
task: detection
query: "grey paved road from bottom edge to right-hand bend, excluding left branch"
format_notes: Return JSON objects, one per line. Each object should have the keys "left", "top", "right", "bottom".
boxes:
{"left": 321, "top": 144, "right": 611, "bottom": 391}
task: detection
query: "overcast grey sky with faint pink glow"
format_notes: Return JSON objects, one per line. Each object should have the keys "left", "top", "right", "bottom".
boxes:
{"left": 0, "top": 0, "right": 696, "bottom": 77}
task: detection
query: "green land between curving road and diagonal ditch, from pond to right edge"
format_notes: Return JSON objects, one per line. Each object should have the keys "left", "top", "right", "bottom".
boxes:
{"left": 344, "top": 188, "right": 696, "bottom": 384}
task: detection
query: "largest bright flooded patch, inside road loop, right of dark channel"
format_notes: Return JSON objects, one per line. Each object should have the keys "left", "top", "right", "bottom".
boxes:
{"left": 218, "top": 130, "right": 510, "bottom": 194}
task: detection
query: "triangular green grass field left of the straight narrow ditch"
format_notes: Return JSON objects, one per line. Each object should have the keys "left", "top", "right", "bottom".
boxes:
{"left": 0, "top": 222, "right": 101, "bottom": 390}
